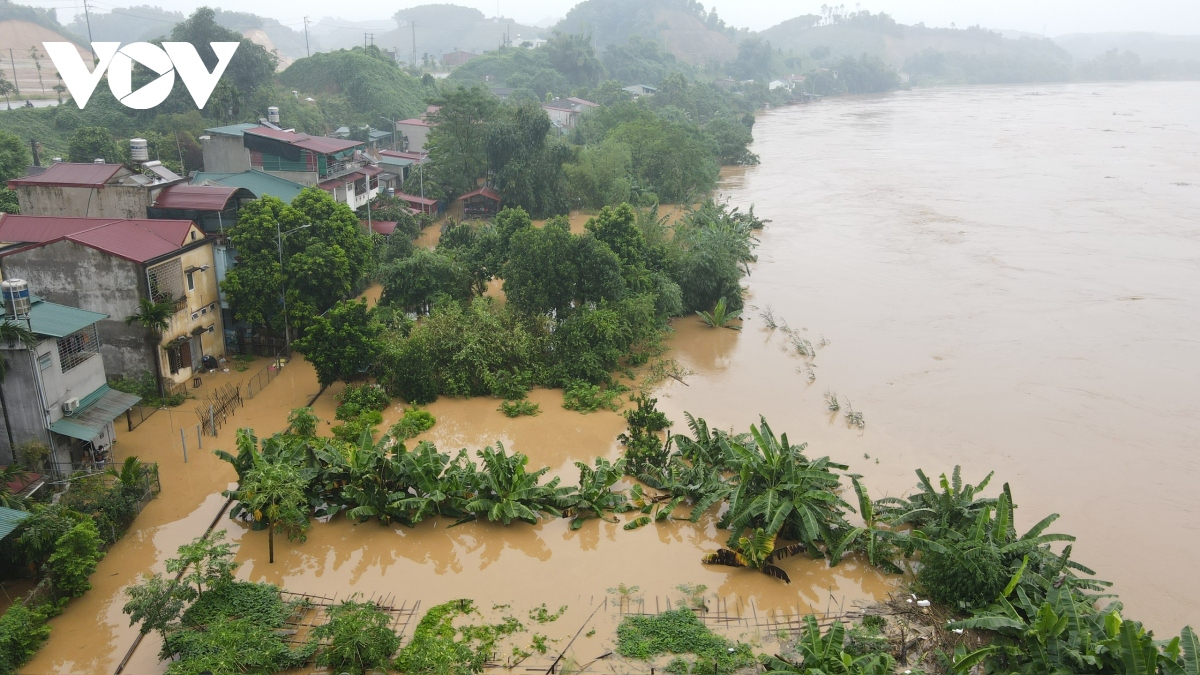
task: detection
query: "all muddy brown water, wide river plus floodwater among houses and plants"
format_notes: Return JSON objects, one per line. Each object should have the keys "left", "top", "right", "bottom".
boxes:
{"left": 23, "top": 83, "right": 1200, "bottom": 674}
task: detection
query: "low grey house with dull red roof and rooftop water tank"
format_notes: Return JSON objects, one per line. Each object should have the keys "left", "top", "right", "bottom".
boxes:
{"left": 8, "top": 162, "right": 184, "bottom": 219}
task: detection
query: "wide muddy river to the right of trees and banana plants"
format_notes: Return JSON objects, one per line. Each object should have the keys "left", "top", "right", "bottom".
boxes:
{"left": 667, "top": 83, "right": 1200, "bottom": 634}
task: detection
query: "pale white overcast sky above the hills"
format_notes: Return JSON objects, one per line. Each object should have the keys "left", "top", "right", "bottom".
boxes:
{"left": 54, "top": 0, "right": 1200, "bottom": 36}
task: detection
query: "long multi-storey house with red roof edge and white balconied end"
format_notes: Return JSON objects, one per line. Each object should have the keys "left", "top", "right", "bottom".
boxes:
{"left": 200, "top": 124, "right": 383, "bottom": 209}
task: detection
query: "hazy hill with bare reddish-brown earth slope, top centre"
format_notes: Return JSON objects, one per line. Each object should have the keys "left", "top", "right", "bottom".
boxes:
{"left": 554, "top": 0, "right": 738, "bottom": 65}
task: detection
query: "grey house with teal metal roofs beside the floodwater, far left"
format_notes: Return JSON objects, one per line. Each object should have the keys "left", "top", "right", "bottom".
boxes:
{"left": 0, "top": 280, "right": 140, "bottom": 476}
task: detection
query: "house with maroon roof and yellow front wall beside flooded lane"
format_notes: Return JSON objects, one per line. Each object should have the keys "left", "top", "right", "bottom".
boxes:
{"left": 0, "top": 215, "right": 224, "bottom": 389}
